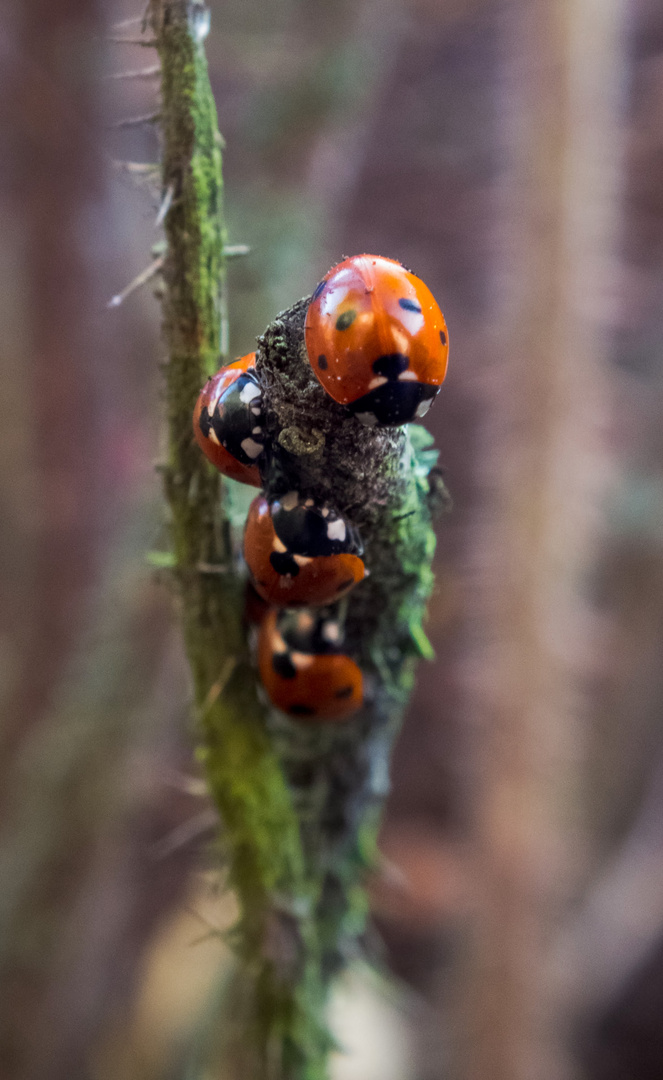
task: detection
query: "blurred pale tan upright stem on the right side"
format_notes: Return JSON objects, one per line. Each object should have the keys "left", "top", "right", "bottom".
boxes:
{"left": 455, "top": 0, "right": 623, "bottom": 1080}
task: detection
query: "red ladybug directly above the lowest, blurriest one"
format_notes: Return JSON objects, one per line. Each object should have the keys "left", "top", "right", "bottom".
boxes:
{"left": 244, "top": 491, "right": 365, "bottom": 607}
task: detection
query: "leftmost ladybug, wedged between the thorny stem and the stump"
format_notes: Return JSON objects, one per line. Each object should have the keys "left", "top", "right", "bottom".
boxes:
{"left": 193, "top": 352, "right": 265, "bottom": 487}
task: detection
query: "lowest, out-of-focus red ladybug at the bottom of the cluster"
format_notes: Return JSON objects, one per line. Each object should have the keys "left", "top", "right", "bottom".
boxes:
{"left": 258, "top": 610, "right": 364, "bottom": 720}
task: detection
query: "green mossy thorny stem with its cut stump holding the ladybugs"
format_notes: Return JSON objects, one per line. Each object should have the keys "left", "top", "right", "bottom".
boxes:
{"left": 148, "top": 0, "right": 444, "bottom": 1080}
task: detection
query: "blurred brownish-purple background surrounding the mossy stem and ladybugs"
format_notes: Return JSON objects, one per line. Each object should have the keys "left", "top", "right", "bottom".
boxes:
{"left": 0, "top": 0, "right": 663, "bottom": 1080}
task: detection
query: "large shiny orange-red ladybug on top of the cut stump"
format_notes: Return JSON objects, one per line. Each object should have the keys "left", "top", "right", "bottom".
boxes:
{"left": 305, "top": 255, "right": 449, "bottom": 428}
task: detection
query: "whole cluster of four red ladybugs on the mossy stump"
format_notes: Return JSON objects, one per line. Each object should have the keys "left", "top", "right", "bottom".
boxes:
{"left": 193, "top": 255, "right": 448, "bottom": 721}
